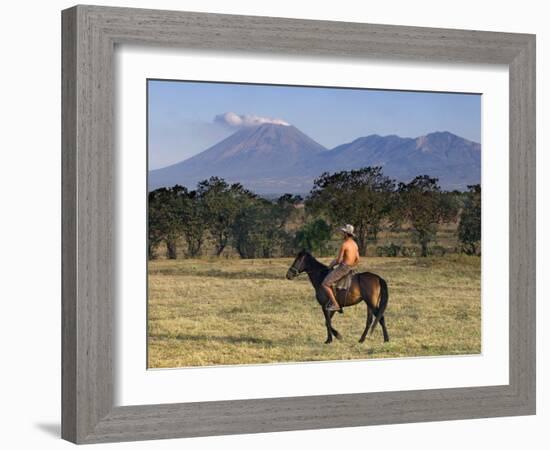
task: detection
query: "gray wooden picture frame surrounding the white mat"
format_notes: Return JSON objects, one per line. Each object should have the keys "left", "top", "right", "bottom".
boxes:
{"left": 62, "top": 6, "right": 535, "bottom": 443}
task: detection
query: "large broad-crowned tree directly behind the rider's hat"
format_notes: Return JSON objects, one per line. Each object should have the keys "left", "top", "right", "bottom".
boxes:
{"left": 306, "top": 167, "right": 395, "bottom": 255}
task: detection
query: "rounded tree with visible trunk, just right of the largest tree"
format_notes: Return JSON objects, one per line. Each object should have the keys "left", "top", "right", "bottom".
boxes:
{"left": 395, "top": 175, "right": 458, "bottom": 256}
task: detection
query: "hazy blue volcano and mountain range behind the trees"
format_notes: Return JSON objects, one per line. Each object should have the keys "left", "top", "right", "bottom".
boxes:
{"left": 149, "top": 124, "right": 481, "bottom": 195}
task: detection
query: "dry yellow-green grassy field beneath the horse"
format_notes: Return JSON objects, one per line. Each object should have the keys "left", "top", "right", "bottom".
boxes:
{"left": 148, "top": 255, "right": 481, "bottom": 368}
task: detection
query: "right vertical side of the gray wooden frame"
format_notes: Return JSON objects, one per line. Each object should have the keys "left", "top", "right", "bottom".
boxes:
{"left": 509, "top": 39, "right": 536, "bottom": 411}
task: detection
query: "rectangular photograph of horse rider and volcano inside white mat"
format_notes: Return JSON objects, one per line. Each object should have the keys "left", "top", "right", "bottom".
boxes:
{"left": 148, "top": 79, "right": 482, "bottom": 368}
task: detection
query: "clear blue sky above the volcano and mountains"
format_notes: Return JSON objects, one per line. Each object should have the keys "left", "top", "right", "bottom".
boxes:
{"left": 148, "top": 80, "right": 481, "bottom": 169}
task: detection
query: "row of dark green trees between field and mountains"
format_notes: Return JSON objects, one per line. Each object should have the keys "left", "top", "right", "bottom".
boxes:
{"left": 148, "top": 167, "right": 481, "bottom": 259}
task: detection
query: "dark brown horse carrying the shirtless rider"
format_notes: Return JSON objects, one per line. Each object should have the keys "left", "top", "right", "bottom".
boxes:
{"left": 286, "top": 250, "right": 390, "bottom": 344}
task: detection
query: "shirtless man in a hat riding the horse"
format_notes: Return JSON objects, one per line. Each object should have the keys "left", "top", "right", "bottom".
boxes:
{"left": 322, "top": 224, "right": 359, "bottom": 311}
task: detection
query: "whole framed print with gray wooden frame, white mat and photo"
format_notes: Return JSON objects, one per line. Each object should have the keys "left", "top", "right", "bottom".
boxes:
{"left": 62, "top": 6, "right": 535, "bottom": 443}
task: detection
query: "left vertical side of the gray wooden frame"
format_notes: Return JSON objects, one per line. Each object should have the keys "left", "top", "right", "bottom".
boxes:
{"left": 62, "top": 4, "right": 113, "bottom": 442}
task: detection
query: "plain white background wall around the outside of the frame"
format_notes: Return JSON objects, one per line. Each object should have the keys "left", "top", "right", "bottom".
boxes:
{"left": 0, "top": 0, "right": 550, "bottom": 450}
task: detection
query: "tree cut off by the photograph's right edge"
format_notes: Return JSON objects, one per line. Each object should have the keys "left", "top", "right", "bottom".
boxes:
{"left": 458, "top": 184, "right": 481, "bottom": 255}
